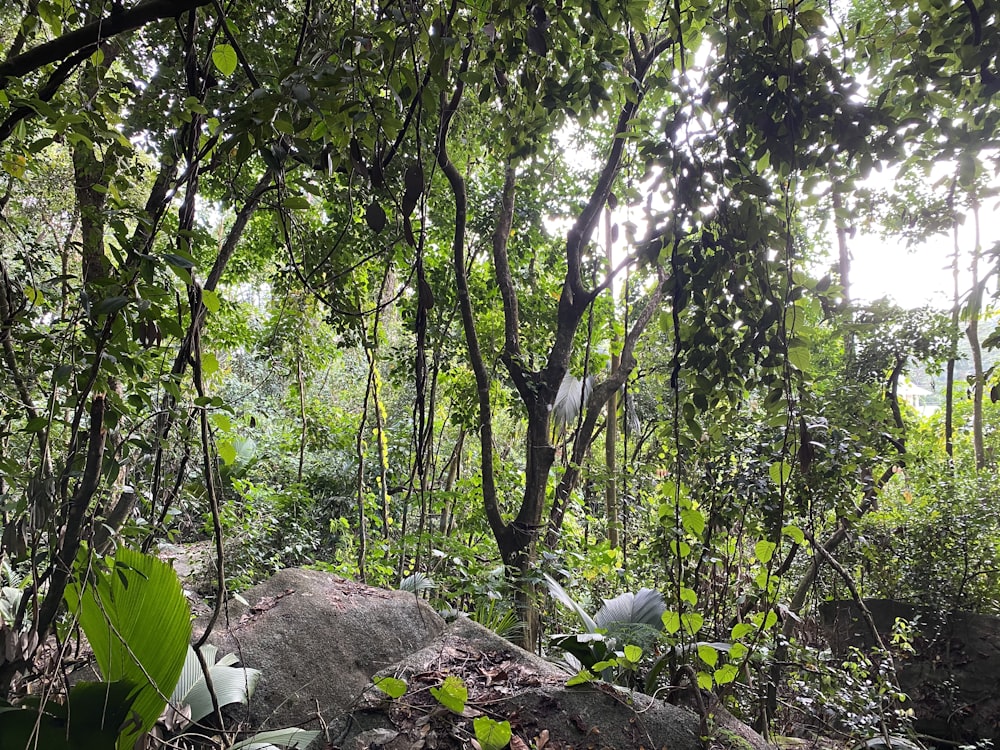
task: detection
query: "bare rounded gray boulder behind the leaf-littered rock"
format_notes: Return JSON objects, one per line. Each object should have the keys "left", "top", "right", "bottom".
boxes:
{"left": 210, "top": 569, "right": 444, "bottom": 729}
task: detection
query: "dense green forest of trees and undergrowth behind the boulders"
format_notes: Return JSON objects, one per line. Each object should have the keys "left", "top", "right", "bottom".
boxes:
{"left": 0, "top": 0, "right": 1000, "bottom": 748}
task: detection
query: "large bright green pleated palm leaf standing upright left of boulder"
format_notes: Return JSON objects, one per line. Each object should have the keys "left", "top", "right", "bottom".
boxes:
{"left": 65, "top": 547, "right": 191, "bottom": 750}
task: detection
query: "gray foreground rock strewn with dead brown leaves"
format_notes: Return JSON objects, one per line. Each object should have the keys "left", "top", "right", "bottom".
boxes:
{"left": 344, "top": 618, "right": 712, "bottom": 750}
